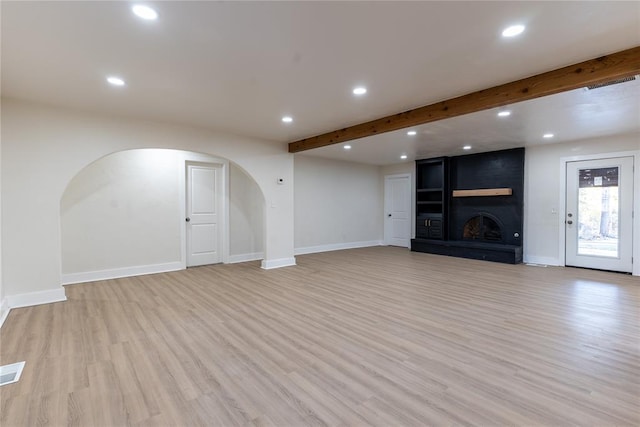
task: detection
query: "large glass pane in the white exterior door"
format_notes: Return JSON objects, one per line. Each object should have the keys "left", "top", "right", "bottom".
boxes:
{"left": 576, "top": 167, "right": 620, "bottom": 258}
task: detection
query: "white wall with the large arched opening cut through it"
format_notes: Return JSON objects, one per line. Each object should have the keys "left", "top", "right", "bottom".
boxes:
{"left": 1, "top": 99, "right": 295, "bottom": 306}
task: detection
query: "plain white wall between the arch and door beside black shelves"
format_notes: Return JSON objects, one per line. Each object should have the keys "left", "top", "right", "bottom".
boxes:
{"left": 294, "top": 154, "right": 383, "bottom": 253}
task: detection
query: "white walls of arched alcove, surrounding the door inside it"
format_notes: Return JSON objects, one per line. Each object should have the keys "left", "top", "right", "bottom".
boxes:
{"left": 60, "top": 148, "right": 266, "bottom": 284}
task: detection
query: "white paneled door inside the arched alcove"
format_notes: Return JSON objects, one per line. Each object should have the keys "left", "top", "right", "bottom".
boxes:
{"left": 186, "top": 164, "right": 224, "bottom": 267}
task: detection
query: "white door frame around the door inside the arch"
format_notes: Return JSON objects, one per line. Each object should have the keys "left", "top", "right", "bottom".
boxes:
{"left": 179, "top": 159, "right": 229, "bottom": 269}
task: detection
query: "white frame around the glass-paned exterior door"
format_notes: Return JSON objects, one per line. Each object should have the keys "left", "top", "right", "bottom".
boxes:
{"left": 558, "top": 150, "right": 640, "bottom": 276}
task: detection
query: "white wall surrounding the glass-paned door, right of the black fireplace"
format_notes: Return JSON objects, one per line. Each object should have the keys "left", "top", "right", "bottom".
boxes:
{"left": 524, "top": 134, "right": 640, "bottom": 272}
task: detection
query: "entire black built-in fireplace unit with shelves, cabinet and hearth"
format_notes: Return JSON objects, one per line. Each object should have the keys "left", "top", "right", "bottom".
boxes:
{"left": 411, "top": 148, "right": 524, "bottom": 264}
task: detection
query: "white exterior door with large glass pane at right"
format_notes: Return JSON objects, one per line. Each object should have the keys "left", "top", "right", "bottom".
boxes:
{"left": 565, "top": 157, "right": 634, "bottom": 273}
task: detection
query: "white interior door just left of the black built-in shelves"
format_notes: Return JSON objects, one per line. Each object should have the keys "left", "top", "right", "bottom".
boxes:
{"left": 384, "top": 175, "right": 411, "bottom": 248}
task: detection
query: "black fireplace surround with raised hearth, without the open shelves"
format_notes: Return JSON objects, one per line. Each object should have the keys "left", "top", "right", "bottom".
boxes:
{"left": 411, "top": 148, "right": 524, "bottom": 264}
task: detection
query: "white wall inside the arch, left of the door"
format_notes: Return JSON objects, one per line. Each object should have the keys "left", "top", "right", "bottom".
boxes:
{"left": 60, "top": 150, "right": 182, "bottom": 275}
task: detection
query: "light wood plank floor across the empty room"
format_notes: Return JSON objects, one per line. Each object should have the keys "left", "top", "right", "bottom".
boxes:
{"left": 0, "top": 247, "right": 640, "bottom": 427}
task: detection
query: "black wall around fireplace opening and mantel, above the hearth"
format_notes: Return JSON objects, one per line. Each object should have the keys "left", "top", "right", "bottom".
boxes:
{"left": 449, "top": 148, "right": 524, "bottom": 246}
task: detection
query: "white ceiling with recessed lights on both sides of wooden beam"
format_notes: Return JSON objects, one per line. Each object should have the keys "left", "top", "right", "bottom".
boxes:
{"left": 1, "top": 1, "right": 640, "bottom": 164}
